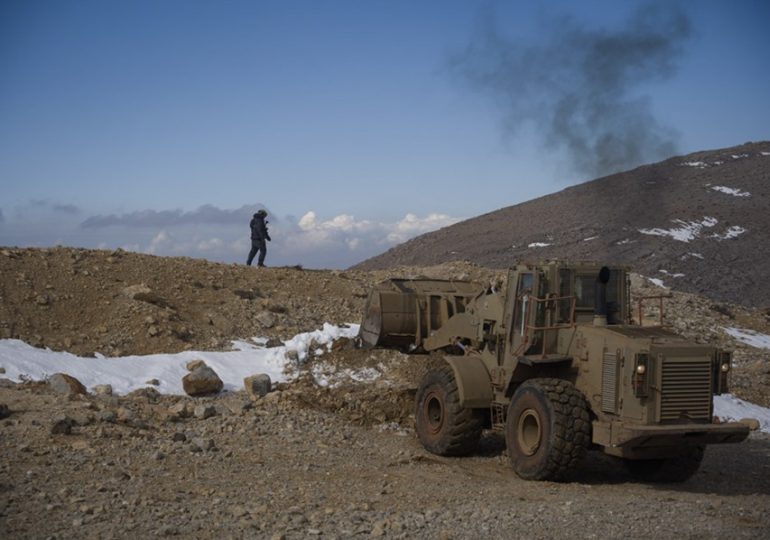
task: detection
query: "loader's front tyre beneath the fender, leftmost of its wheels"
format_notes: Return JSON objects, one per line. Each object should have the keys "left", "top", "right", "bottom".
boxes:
{"left": 414, "top": 365, "right": 484, "bottom": 456}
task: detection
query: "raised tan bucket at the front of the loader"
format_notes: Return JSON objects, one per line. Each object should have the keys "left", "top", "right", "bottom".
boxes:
{"left": 359, "top": 279, "right": 481, "bottom": 350}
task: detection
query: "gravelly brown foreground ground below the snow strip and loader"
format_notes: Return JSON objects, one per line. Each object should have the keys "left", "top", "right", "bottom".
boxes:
{"left": 0, "top": 383, "right": 770, "bottom": 539}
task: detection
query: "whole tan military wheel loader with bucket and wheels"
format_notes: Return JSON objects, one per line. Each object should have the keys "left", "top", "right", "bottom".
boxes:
{"left": 359, "top": 262, "right": 750, "bottom": 482}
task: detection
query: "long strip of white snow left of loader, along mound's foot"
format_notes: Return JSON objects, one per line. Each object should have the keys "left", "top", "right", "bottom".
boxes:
{"left": 0, "top": 323, "right": 358, "bottom": 394}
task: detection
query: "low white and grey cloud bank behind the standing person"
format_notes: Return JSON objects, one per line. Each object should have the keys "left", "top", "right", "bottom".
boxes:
{"left": 0, "top": 201, "right": 461, "bottom": 268}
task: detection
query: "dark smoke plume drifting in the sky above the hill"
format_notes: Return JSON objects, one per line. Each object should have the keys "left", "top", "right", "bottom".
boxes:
{"left": 450, "top": 4, "right": 691, "bottom": 178}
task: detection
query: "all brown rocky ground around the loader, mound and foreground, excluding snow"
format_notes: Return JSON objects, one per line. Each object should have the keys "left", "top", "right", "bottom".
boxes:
{"left": 0, "top": 248, "right": 770, "bottom": 539}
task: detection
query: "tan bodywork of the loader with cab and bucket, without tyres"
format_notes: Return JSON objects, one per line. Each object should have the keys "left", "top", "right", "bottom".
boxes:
{"left": 362, "top": 262, "right": 749, "bottom": 458}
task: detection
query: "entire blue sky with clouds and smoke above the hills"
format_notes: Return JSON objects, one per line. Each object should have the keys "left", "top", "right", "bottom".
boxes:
{"left": 0, "top": 0, "right": 770, "bottom": 267}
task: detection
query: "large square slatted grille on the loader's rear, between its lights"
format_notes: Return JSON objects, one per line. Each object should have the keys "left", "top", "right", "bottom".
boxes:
{"left": 660, "top": 358, "right": 712, "bottom": 422}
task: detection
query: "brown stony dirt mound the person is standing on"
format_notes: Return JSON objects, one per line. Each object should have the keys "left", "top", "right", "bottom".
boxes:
{"left": 0, "top": 248, "right": 500, "bottom": 356}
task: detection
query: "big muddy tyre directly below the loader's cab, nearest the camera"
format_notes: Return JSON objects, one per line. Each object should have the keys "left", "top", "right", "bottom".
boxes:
{"left": 505, "top": 379, "right": 591, "bottom": 480}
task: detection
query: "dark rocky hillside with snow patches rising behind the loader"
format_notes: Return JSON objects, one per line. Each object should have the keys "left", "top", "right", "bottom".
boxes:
{"left": 354, "top": 142, "right": 770, "bottom": 307}
